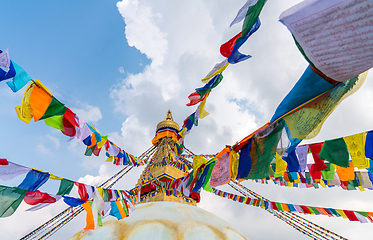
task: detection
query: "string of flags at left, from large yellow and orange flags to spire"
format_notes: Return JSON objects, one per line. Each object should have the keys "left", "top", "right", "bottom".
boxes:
{"left": 10, "top": 80, "right": 145, "bottom": 166}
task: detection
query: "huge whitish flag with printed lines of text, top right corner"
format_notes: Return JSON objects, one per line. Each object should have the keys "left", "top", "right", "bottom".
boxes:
{"left": 280, "top": 0, "right": 373, "bottom": 82}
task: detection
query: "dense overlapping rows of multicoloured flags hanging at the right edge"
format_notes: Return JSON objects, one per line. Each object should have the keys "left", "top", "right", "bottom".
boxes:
{"left": 244, "top": 128, "right": 373, "bottom": 191}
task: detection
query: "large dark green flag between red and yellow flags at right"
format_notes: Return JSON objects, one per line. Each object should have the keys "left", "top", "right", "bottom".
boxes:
{"left": 319, "top": 138, "right": 350, "bottom": 167}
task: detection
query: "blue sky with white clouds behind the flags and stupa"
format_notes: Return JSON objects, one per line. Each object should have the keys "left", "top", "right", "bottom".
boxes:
{"left": 0, "top": 0, "right": 373, "bottom": 240}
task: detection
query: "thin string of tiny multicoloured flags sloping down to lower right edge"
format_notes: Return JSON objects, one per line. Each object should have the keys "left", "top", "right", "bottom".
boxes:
{"left": 213, "top": 188, "right": 373, "bottom": 223}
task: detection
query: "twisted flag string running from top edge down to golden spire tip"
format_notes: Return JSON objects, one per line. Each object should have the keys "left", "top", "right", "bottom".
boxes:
{"left": 178, "top": 0, "right": 266, "bottom": 146}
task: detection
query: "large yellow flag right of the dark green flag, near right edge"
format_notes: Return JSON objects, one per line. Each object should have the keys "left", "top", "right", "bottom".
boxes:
{"left": 343, "top": 132, "right": 370, "bottom": 169}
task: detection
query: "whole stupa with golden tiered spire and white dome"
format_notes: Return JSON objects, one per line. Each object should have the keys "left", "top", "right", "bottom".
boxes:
{"left": 71, "top": 111, "right": 247, "bottom": 240}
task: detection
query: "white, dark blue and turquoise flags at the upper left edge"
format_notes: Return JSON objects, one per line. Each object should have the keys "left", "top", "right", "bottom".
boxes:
{"left": 0, "top": 49, "right": 32, "bottom": 92}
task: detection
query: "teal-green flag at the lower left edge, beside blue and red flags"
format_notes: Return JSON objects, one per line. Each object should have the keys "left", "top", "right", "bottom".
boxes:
{"left": 0, "top": 185, "right": 27, "bottom": 217}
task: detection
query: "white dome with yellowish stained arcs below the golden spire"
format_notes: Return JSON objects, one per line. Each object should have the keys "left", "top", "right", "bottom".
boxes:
{"left": 71, "top": 202, "right": 247, "bottom": 240}
